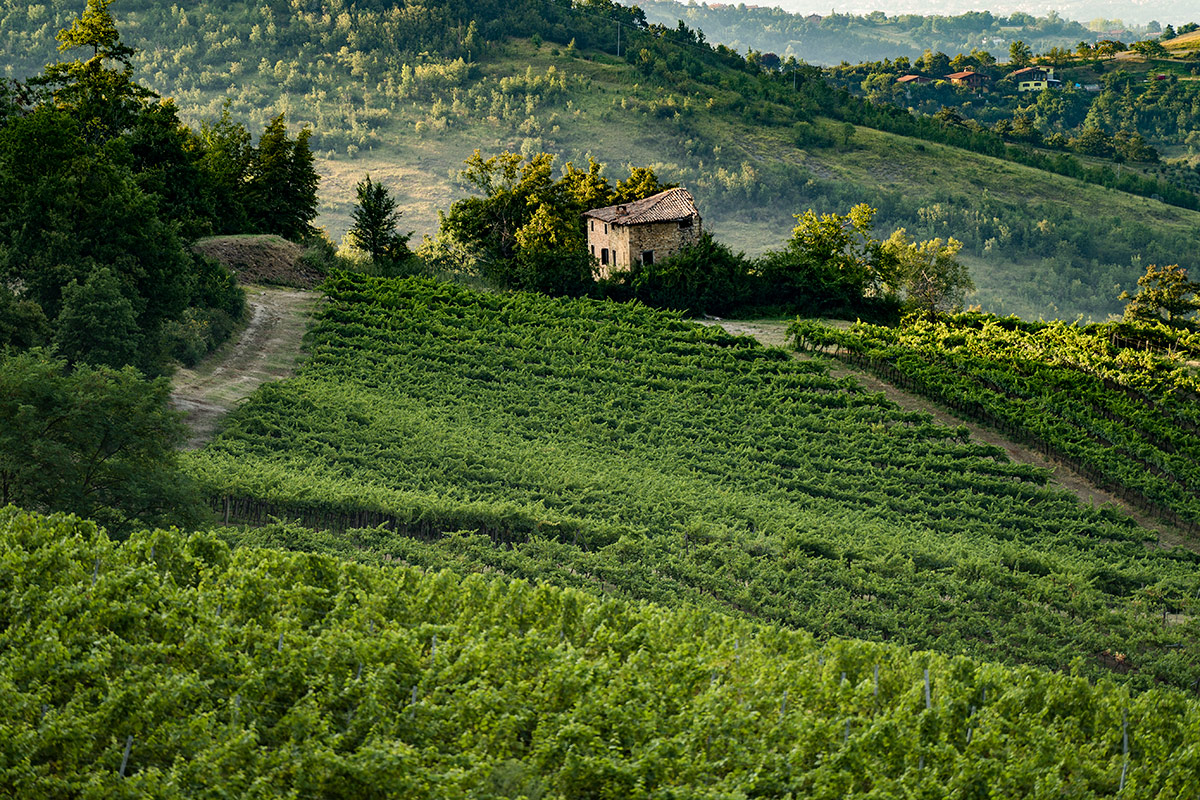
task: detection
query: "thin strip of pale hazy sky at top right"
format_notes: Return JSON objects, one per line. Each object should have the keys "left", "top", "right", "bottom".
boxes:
{"left": 753, "top": 0, "right": 1200, "bottom": 25}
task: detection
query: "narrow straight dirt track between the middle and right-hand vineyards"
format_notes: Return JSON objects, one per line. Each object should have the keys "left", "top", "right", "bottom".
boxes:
{"left": 696, "top": 319, "right": 1200, "bottom": 551}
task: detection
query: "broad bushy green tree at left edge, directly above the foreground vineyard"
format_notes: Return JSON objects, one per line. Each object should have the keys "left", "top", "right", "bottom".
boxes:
{"left": 0, "top": 350, "right": 200, "bottom": 535}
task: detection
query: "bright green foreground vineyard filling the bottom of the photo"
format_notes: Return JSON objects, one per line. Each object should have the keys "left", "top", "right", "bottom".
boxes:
{"left": 0, "top": 509, "right": 1200, "bottom": 800}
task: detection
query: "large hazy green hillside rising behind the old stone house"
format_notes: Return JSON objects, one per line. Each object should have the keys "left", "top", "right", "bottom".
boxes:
{"left": 9, "top": 0, "right": 1200, "bottom": 318}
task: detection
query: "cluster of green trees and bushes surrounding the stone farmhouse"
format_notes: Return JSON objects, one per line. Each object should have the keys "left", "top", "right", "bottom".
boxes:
{"left": 408, "top": 151, "right": 973, "bottom": 319}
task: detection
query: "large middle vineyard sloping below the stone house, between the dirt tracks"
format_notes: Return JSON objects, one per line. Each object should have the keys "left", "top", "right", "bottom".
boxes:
{"left": 188, "top": 275, "right": 1200, "bottom": 688}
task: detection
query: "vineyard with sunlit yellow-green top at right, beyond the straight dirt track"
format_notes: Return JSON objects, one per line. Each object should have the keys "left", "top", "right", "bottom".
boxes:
{"left": 790, "top": 314, "right": 1200, "bottom": 536}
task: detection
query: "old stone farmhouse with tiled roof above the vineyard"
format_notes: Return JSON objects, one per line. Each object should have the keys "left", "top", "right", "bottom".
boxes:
{"left": 583, "top": 188, "right": 701, "bottom": 277}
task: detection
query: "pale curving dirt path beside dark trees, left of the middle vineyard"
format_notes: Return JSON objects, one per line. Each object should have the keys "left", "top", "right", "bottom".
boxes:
{"left": 172, "top": 285, "right": 320, "bottom": 450}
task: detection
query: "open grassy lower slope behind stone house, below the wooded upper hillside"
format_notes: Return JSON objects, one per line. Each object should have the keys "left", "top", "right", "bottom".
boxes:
{"left": 307, "top": 42, "right": 1200, "bottom": 319}
